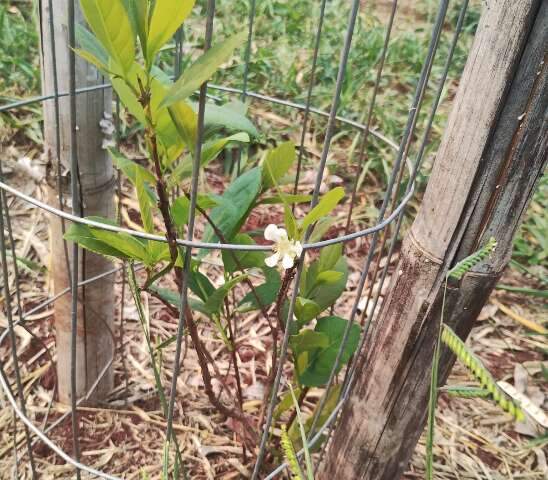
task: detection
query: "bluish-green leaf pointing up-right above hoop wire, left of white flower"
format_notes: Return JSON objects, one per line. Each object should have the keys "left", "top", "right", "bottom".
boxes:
{"left": 204, "top": 167, "right": 261, "bottom": 242}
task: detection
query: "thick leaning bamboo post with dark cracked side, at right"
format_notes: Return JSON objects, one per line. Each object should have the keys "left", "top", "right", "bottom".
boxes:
{"left": 319, "top": 0, "right": 548, "bottom": 480}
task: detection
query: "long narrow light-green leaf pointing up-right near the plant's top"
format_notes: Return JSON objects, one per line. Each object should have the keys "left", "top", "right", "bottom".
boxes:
{"left": 161, "top": 31, "right": 247, "bottom": 107}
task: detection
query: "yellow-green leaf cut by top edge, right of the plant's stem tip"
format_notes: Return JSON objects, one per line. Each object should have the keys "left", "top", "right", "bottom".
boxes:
{"left": 146, "top": 0, "right": 195, "bottom": 63}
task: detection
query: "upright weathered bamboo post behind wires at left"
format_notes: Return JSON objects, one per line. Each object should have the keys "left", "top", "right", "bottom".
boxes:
{"left": 40, "top": 0, "right": 115, "bottom": 403}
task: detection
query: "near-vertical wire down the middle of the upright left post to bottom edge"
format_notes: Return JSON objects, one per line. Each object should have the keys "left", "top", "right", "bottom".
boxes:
{"left": 68, "top": 0, "right": 81, "bottom": 480}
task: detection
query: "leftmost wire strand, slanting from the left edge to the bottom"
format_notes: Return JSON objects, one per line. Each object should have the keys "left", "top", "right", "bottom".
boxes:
{"left": 0, "top": 187, "right": 36, "bottom": 478}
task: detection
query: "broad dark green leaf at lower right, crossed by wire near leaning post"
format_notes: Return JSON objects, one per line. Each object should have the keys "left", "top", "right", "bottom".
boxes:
{"left": 299, "top": 316, "right": 360, "bottom": 387}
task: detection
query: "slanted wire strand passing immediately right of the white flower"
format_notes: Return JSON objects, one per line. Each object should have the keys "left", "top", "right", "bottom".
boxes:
{"left": 251, "top": 0, "right": 360, "bottom": 480}
